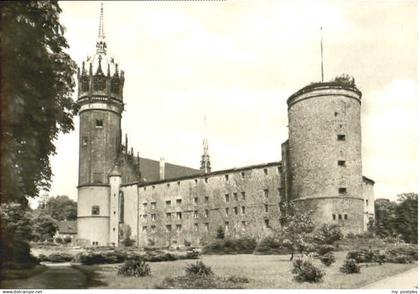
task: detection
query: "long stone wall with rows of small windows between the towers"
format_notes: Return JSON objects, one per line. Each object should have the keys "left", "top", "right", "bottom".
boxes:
{"left": 138, "top": 162, "right": 280, "bottom": 247}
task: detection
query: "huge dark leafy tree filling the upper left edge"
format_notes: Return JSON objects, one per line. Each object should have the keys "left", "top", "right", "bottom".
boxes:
{"left": 0, "top": 1, "right": 76, "bottom": 205}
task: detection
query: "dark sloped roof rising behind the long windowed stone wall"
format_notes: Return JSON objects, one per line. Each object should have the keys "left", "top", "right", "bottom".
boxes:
{"left": 140, "top": 157, "right": 201, "bottom": 182}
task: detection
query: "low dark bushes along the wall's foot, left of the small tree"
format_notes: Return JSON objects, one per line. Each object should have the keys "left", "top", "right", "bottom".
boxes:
{"left": 201, "top": 238, "right": 257, "bottom": 254}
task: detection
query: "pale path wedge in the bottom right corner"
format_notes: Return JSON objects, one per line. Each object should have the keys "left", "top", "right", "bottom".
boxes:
{"left": 363, "top": 267, "right": 418, "bottom": 289}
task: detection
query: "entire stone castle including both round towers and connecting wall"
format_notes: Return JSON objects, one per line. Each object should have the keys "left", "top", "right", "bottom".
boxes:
{"left": 77, "top": 8, "right": 374, "bottom": 247}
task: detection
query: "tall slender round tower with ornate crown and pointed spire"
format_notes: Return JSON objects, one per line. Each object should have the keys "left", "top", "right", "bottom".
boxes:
{"left": 77, "top": 7, "right": 124, "bottom": 245}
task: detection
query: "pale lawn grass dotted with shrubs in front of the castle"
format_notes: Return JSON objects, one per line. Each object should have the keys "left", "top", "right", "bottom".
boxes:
{"left": 82, "top": 252, "right": 417, "bottom": 289}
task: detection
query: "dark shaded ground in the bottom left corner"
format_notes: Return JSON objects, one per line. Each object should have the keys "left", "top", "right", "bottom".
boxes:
{"left": 1, "top": 264, "right": 87, "bottom": 289}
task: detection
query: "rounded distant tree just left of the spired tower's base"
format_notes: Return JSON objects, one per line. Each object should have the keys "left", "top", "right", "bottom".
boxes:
{"left": 44, "top": 195, "right": 77, "bottom": 221}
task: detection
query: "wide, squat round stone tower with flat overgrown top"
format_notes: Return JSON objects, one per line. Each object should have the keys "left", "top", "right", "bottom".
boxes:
{"left": 287, "top": 79, "right": 363, "bottom": 232}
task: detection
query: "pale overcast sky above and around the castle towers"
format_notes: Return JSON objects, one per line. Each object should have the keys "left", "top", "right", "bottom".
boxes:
{"left": 37, "top": 0, "right": 418, "bottom": 207}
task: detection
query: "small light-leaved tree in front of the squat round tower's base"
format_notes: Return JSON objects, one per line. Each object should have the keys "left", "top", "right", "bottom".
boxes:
{"left": 280, "top": 203, "right": 315, "bottom": 260}
